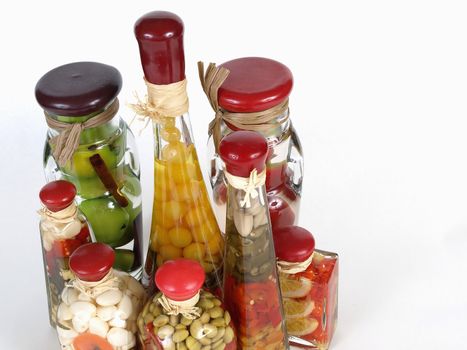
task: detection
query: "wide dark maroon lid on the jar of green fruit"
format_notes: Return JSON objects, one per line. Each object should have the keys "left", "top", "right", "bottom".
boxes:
{"left": 36, "top": 62, "right": 122, "bottom": 117}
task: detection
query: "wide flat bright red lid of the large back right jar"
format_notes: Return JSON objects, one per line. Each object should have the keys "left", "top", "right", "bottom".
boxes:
{"left": 218, "top": 57, "right": 293, "bottom": 113}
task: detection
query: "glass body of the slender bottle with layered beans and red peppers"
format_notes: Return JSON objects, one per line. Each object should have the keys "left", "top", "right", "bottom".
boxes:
{"left": 224, "top": 185, "right": 289, "bottom": 350}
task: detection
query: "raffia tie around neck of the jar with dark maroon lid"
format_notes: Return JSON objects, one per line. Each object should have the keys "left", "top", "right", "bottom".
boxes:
{"left": 44, "top": 98, "right": 119, "bottom": 166}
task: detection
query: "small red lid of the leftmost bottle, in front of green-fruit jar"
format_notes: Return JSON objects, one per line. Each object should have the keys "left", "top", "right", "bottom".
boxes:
{"left": 39, "top": 180, "right": 76, "bottom": 211}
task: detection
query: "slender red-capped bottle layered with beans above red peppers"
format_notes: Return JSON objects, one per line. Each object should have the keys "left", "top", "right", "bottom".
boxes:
{"left": 219, "top": 131, "right": 289, "bottom": 350}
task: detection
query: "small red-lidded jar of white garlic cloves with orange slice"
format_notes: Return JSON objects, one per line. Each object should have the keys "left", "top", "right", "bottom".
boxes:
{"left": 57, "top": 243, "right": 146, "bottom": 350}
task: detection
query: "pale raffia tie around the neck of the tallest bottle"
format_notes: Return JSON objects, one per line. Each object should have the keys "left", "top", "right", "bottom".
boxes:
{"left": 129, "top": 79, "right": 189, "bottom": 129}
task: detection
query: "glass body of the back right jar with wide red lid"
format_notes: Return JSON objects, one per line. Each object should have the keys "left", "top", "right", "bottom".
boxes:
{"left": 208, "top": 111, "right": 303, "bottom": 232}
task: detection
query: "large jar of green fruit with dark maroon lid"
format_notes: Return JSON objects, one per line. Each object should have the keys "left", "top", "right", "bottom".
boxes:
{"left": 36, "top": 62, "right": 142, "bottom": 279}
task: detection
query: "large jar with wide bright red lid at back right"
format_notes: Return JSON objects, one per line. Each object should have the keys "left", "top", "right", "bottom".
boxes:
{"left": 200, "top": 57, "right": 303, "bottom": 230}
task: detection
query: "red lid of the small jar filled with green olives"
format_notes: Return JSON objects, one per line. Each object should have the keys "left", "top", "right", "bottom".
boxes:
{"left": 155, "top": 258, "right": 206, "bottom": 301}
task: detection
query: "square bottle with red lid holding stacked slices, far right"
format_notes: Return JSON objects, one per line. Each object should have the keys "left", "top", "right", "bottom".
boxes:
{"left": 274, "top": 226, "right": 338, "bottom": 349}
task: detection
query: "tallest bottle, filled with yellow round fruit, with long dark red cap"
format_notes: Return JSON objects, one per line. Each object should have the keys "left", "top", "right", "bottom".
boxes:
{"left": 135, "top": 11, "right": 224, "bottom": 291}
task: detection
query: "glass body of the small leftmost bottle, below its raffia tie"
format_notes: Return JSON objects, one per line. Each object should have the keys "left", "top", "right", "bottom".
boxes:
{"left": 39, "top": 211, "right": 91, "bottom": 327}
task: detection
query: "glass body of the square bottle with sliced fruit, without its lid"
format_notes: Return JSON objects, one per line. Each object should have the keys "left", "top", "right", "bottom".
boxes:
{"left": 279, "top": 250, "right": 339, "bottom": 350}
